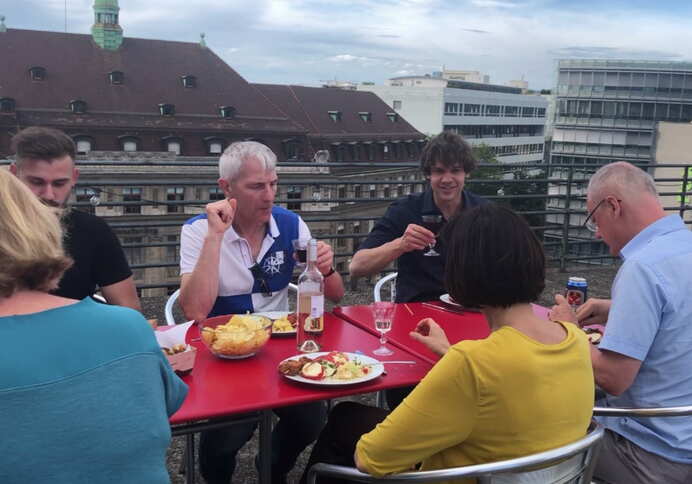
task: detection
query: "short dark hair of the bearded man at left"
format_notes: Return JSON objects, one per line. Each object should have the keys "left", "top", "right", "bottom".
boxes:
{"left": 11, "top": 126, "right": 76, "bottom": 164}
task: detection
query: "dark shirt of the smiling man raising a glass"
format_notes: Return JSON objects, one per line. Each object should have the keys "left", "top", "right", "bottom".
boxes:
{"left": 359, "top": 187, "right": 487, "bottom": 302}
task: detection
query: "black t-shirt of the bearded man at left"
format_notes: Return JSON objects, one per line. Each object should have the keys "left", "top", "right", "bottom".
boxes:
{"left": 54, "top": 210, "right": 132, "bottom": 299}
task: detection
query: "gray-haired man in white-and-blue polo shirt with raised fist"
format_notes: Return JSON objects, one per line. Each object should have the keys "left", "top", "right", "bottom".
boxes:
{"left": 180, "top": 141, "right": 344, "bottom": 484}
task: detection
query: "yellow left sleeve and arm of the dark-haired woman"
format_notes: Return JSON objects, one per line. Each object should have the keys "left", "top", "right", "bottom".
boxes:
{"left": 355, "top": 351, "right": 478, "bottom": 477}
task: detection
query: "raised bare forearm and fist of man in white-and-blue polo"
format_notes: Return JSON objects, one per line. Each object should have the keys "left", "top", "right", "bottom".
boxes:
{"left": 180, "top": 199, "right": 236, "bottom": 321}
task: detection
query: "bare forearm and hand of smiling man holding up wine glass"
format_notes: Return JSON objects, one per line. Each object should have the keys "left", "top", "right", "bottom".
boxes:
{"left": 349, "top": 224, "right": 435, "bottom": 277}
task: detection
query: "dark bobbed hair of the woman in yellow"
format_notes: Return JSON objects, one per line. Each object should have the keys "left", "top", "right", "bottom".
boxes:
{"left": 444, "top": 203, "right": 545, "bottom": 308}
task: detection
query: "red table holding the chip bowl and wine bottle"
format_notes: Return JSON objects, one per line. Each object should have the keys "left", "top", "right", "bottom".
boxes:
{"left": 170, "top": 314, "right": 432, "bottom": 482}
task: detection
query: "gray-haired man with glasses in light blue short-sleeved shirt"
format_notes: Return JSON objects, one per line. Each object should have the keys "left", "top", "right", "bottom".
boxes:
{"left": 550, "top": 162, "right": 692, "bottom": 484}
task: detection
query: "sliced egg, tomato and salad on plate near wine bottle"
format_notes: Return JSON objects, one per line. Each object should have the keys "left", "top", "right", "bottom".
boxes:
{"left": 279, "top": 351, "right": 372, "bottom": 380}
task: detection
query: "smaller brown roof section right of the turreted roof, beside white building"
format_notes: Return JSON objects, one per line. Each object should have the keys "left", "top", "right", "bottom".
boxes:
{"left": 253, "top": 84, "right": 425, "bottom": 139}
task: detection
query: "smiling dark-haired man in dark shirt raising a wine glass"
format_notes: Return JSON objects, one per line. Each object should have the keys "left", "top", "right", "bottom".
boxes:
{"left": 350, "top": 131, "right": 486, "bottom": 302}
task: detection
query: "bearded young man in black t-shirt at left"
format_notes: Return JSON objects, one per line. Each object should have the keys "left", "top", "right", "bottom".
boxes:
{"left": 10, "top": 127, "right": 141, "bottom": 311}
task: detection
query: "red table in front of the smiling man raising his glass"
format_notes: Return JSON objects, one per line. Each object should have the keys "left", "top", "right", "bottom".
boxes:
{"left": 334, "top": 302, "right": 548, "bottom": 364}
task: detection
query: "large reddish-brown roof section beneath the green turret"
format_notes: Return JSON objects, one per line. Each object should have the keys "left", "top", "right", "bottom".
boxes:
{"left": 0, "top": 29, "right": 303, "bottom": 133}
